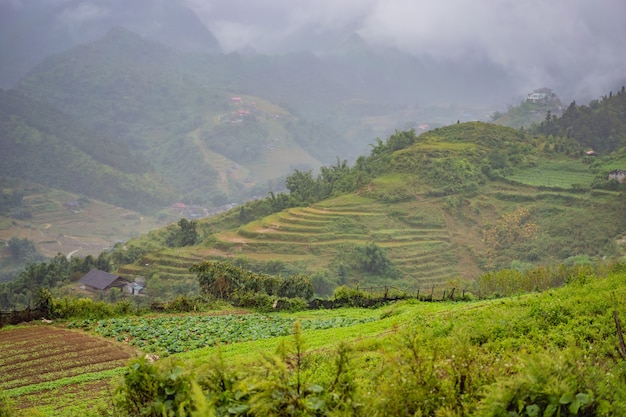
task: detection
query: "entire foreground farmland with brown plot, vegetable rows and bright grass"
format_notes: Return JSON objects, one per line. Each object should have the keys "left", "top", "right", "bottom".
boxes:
{"left": 0, "top": 268, "right": 626, "bottom": 416}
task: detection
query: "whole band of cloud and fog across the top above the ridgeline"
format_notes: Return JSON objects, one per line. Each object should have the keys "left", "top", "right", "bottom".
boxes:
{"left": 0, "top": 0, "right": 626, "bottom": 99}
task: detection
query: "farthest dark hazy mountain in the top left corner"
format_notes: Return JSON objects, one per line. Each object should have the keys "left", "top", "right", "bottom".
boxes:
{"left": 0, "top": 0, "right": 219, "bottom": 88}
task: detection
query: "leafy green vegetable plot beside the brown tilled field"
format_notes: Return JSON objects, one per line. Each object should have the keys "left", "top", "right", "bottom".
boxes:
{"left": 70, "top": 314, "right": 375, "bottom": 355}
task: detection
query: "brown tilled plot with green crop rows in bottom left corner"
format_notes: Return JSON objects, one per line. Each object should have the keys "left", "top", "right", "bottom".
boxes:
{"left": 0, "top": 325, "right": 134, "bottom": 408}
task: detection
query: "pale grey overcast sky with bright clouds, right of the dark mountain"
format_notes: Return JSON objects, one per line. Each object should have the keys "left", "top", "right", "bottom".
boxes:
{"left": 185, "top": 0, "right": 626, "bottom": 97}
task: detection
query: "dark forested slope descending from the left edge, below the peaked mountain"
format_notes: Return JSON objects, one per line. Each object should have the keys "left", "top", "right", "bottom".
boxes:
{"left": 0, "top": 91, "right": 176, "bottom": 210}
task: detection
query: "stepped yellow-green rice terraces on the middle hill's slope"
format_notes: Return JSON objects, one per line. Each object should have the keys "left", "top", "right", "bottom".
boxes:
{"left": 136, "top": 196, "right": 458, "bottom": 287}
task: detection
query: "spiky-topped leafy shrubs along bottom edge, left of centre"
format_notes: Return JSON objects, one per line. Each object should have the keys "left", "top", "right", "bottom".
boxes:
{"left": 107, "top": 322, "right": 362, "bottom": 417}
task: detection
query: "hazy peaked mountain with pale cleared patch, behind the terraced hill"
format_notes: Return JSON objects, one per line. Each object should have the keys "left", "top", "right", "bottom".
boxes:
{"left": 11, "top": 29, "right": 338, "bottom": 206}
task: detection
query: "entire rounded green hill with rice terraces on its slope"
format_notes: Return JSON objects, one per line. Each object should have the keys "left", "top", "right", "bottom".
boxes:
{"left": 105, "top": 122, "right": 626, "bottom": 293}
